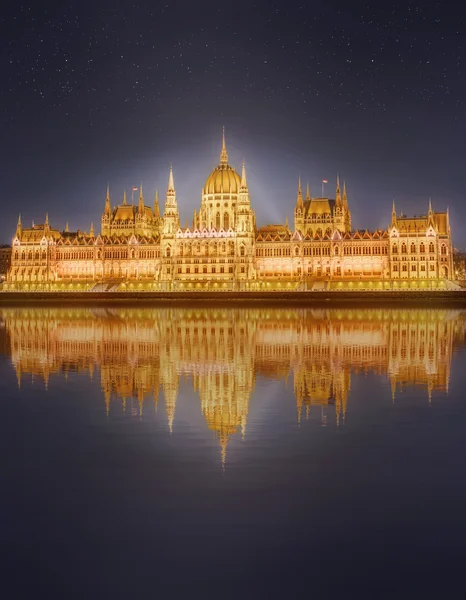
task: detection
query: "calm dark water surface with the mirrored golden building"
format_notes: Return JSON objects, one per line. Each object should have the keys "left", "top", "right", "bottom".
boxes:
{"left": 0, "top": 308, "right": 466, "bottom": 599}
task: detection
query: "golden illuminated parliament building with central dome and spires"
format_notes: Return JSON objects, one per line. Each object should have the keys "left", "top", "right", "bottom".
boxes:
{"left": 3, "top": 135, "right": 454, "bottom": 291}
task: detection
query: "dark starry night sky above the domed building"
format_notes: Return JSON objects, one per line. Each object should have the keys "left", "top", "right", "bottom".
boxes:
{"left": 0, "top": 0, "right": 466, "bottom": 247}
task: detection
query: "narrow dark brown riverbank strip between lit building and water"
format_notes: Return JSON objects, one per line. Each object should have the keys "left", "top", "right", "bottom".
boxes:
{"left": 0, "top": 290, "right": 466, "bottom": 308}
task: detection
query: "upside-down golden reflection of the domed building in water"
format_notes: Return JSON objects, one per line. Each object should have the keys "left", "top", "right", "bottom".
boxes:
{"left": 0, "top": 308, "right": 466, "bottom": 461}
